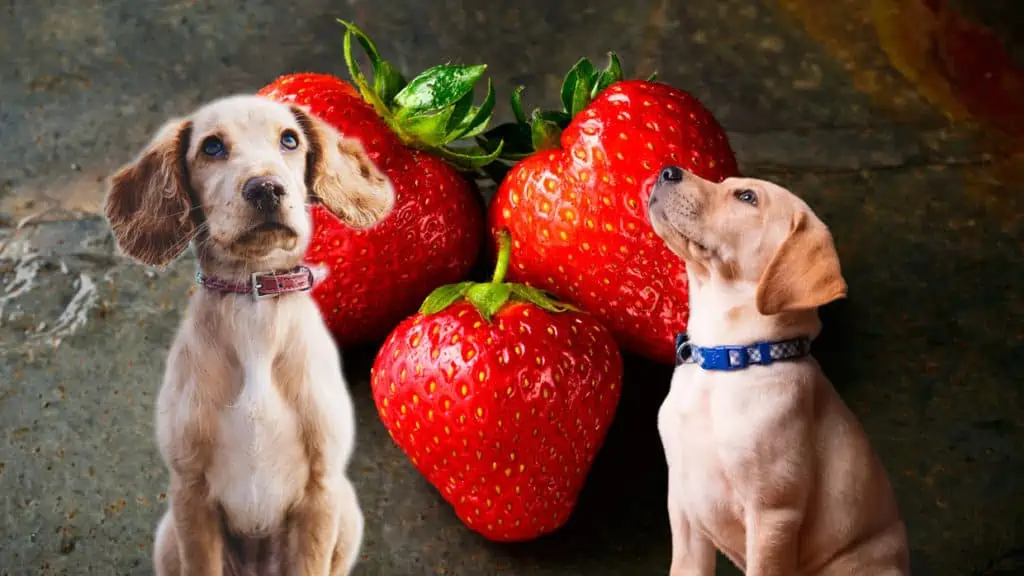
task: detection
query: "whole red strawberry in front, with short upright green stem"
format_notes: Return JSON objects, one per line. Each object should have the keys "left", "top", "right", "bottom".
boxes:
{"left": 371, "top": 230, "right": 623, "bottom": 541}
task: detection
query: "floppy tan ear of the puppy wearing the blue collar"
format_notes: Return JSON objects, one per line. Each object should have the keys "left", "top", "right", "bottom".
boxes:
{"left": 757, "top": 211, "right": 847, "bottom": 316}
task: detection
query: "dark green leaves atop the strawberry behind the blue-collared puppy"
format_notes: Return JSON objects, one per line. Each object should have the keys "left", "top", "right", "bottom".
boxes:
{"left": 476, "top": 52, "right": 657, "bottom": 182}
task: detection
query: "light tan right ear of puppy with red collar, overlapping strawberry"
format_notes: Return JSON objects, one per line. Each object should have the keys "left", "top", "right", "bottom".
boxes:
{"left": 292, "top": 107, "right": 394, "bottom": 228}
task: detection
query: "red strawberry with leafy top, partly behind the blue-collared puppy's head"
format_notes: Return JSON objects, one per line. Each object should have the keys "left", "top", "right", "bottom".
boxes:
{"left": 484, "top": 53, "right": 738, "bottom": 362}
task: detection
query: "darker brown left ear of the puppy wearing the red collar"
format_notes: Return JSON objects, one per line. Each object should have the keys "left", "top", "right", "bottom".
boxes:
{"left": 103, "top": 120, "right": 196, "bottom": 265}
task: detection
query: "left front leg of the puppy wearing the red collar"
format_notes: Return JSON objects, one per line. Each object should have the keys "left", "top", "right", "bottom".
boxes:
{"left": 171, "top": 474, "right": 224, "bottom": 576}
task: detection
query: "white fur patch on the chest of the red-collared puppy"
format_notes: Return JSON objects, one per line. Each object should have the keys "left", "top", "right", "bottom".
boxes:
{"left": 207, "top": 366, "right": 308, "bottom": 535}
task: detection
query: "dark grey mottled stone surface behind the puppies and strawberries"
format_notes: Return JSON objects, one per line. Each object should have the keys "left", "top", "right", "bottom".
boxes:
{"left": 0, "top": 0, "right": 1024, "bottom": 576}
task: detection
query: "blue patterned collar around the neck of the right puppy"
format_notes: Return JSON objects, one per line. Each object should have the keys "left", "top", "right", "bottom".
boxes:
{"left": 676, "top": 332, "right": 811, "bottom": 371}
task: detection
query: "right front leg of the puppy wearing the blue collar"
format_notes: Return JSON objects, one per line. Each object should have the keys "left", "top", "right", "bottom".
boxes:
{"left": 746, "top": 508, "right": 804, "bottom": 576}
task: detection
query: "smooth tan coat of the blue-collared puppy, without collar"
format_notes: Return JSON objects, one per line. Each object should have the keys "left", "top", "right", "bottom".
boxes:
{"left": 648, "top": 173, "right": 909, "bottom": 576}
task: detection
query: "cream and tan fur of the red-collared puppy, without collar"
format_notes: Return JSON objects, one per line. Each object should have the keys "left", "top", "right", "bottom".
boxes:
{"left": 105, "top": 96, "right": 393, "bottom": 576}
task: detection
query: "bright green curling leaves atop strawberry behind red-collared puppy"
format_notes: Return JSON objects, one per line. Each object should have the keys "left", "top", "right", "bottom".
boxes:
{"left": 338, "top": 19, "right": 504, "bottom": 172}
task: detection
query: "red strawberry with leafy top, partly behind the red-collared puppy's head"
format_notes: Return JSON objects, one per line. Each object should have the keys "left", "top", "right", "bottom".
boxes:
{"left": 259, "top": 23, "right": 505, "bottom": 345}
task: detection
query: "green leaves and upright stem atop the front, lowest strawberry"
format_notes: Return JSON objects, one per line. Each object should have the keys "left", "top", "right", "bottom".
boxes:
{"left": 420, "top": 231, "right": 579, "bottom": 323}
